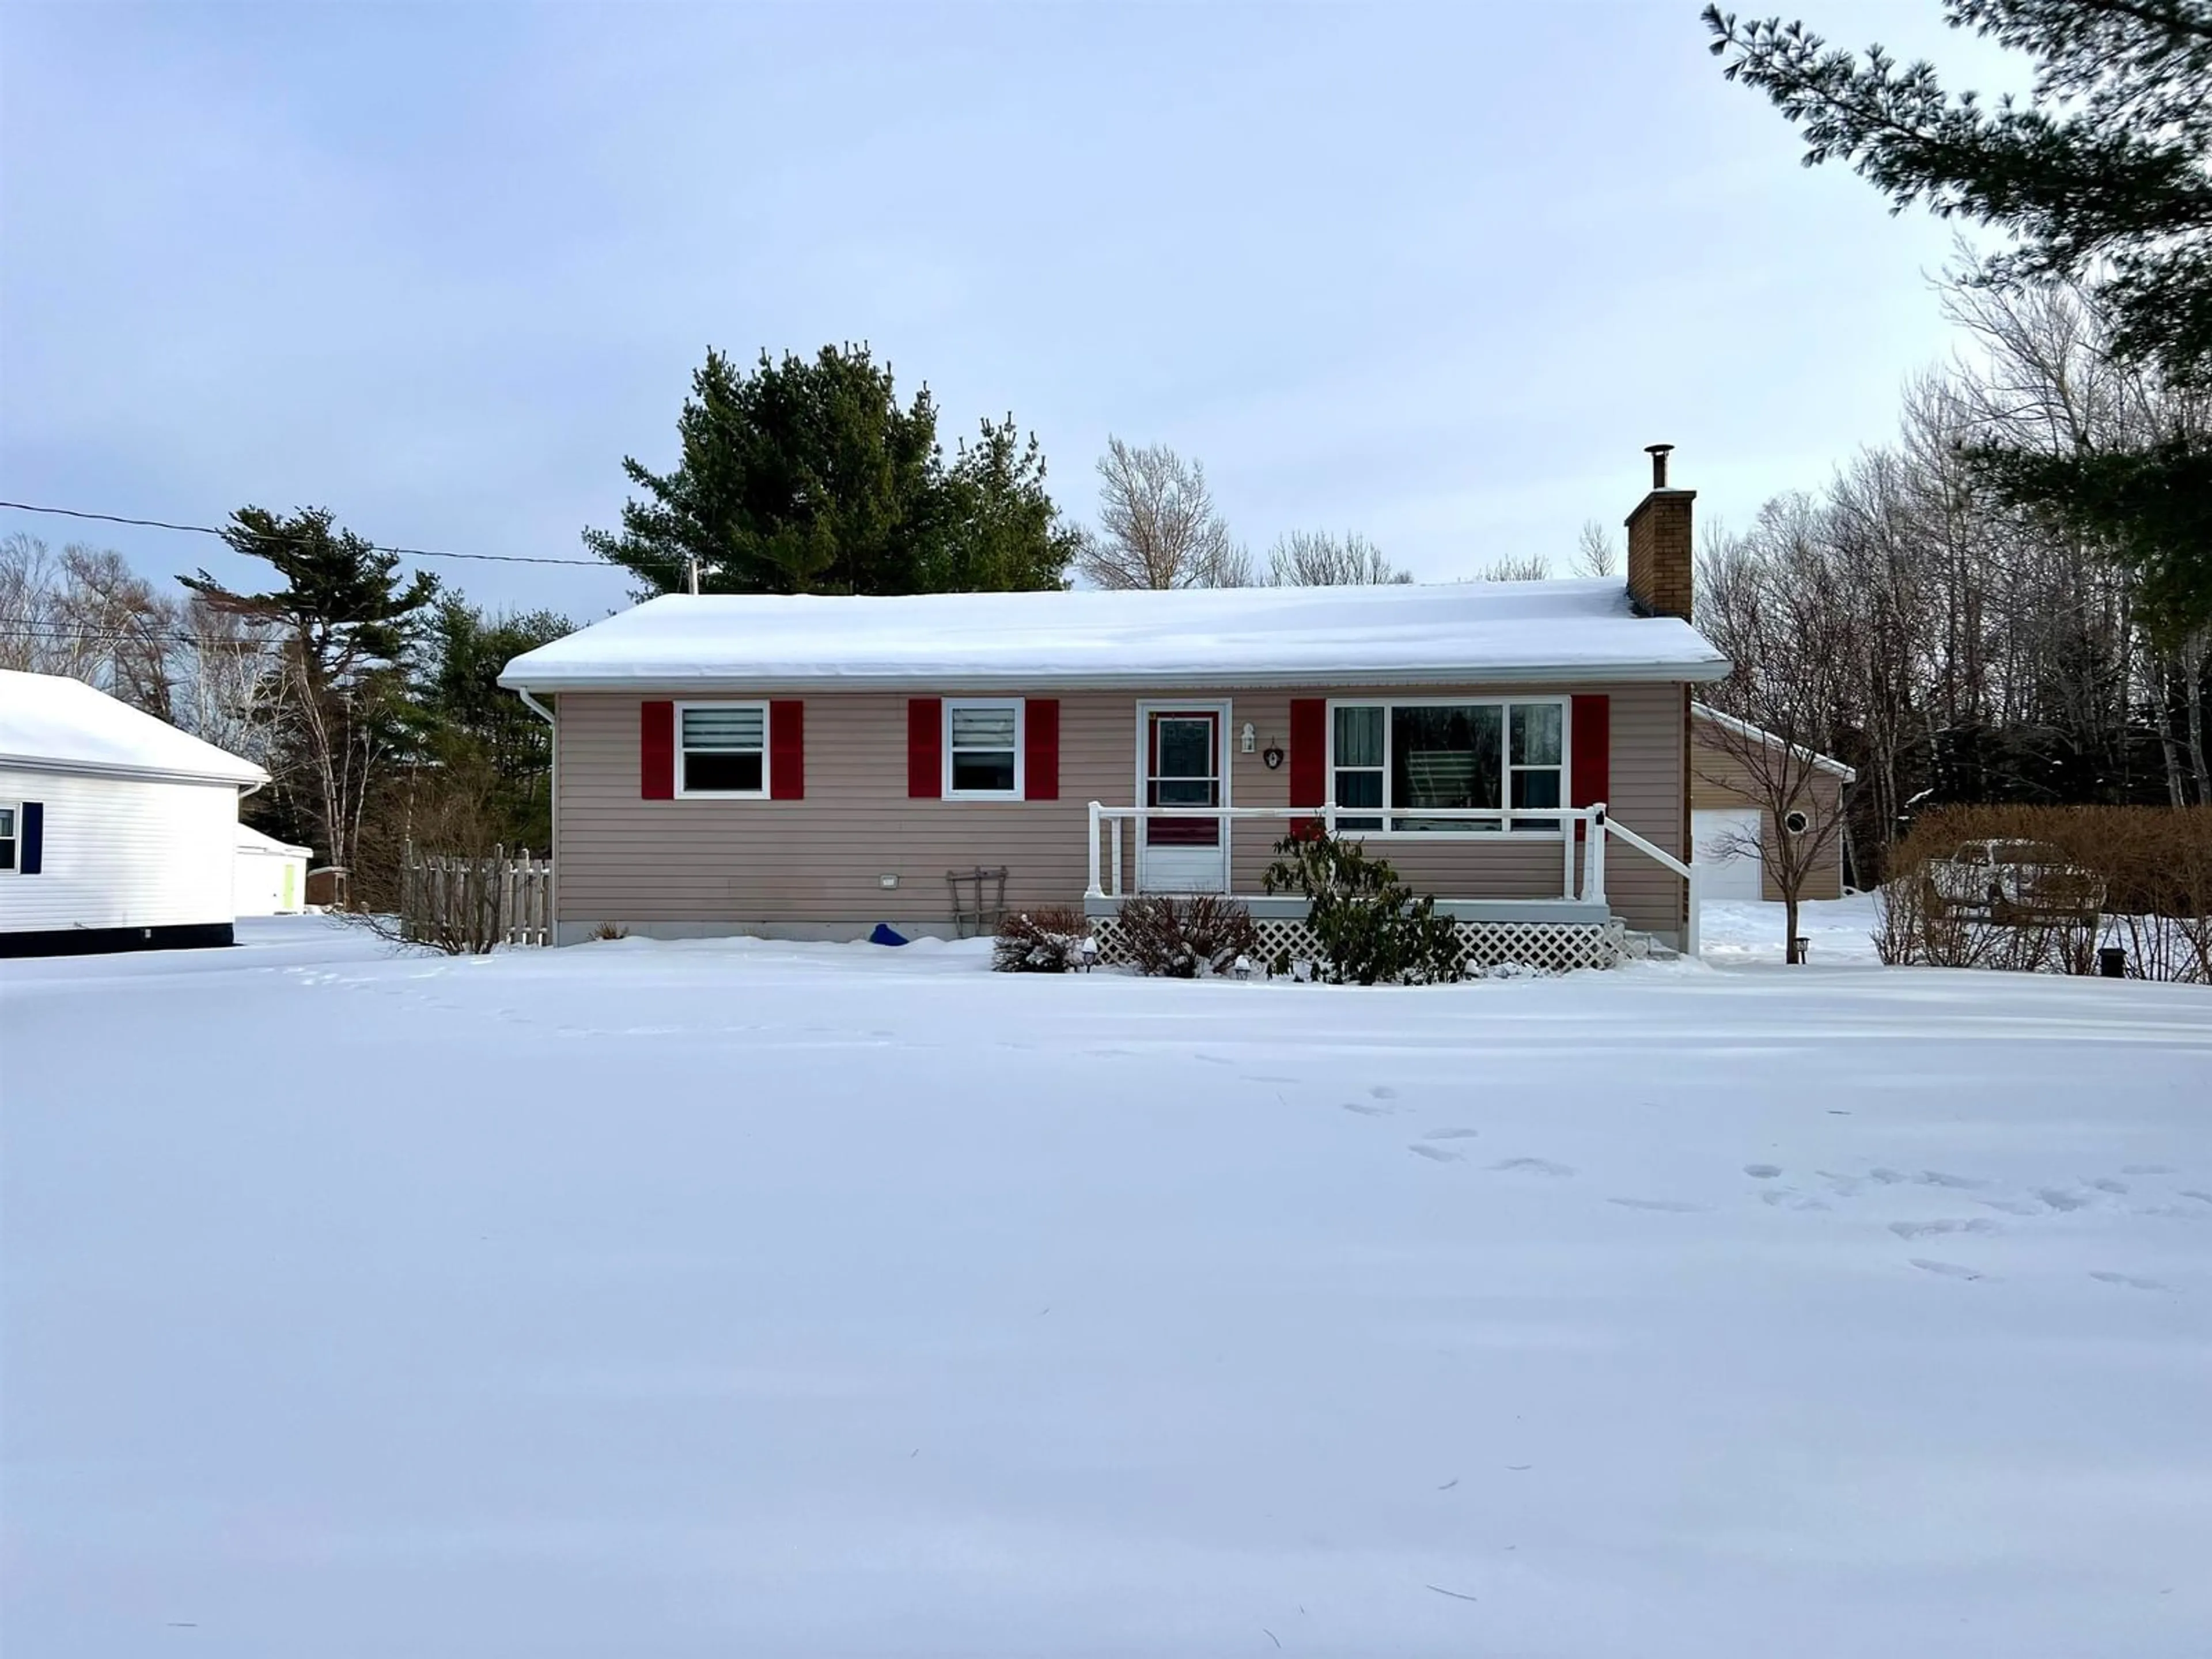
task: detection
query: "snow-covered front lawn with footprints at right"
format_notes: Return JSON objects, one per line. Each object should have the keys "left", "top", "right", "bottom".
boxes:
{"left": 0, "top": 918, "right": 2212, "bottom": 1659}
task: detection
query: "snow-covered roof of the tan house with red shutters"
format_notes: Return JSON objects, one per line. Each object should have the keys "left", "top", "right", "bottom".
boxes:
{"left": 500, "top": 579, "right": 1728, "bottom": 692}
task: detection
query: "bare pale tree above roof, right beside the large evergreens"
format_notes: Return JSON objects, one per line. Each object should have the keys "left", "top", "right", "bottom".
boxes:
{"left": 1075, "top": 438, "right": 1252, "bottom": 588}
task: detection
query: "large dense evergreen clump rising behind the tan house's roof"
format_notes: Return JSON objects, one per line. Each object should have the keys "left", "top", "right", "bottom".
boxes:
{"left": 584, "top": 345, "right": 1066, "bottom": 597}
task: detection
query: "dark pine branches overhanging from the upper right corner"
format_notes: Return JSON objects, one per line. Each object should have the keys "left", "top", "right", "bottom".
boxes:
{"left": 1706, "top": 0, "right": 2212, "bottom": 626}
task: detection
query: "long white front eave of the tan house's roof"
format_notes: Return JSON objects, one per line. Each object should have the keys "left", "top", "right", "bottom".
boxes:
{"left": 500, "top": 657, "right": 1728, "bottom": 697}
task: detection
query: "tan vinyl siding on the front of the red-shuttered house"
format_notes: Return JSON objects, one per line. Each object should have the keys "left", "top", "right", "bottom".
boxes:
{"left": 555, "top": 685, "right": 1685, "bottom": 931}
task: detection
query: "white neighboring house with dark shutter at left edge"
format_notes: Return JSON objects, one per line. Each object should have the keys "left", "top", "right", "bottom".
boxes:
{"left": 0, "top": 671, "right": 268, "bottom": 956}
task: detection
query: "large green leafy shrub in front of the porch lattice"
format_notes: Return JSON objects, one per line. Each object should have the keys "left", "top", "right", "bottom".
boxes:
{"left": 1267, "top": 825, "right": 1460, "bottom": 984}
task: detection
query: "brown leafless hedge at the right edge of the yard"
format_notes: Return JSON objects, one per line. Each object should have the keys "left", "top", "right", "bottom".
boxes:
{"left": 1873, "top": 805, "right": 2212, "bottom": 984}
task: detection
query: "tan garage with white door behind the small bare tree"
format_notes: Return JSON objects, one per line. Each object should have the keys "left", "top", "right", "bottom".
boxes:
{"left": 1690, "top": 703, "right": 1858, "bottom": 900}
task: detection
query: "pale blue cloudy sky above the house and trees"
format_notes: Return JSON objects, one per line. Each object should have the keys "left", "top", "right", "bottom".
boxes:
{"left": 0, "top": 0, "right": 2011, "bottom": 617}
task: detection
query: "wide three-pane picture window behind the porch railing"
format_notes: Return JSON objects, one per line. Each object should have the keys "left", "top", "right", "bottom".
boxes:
{"left": 1330, "top": 697, "right": 1566, "bottom": 834}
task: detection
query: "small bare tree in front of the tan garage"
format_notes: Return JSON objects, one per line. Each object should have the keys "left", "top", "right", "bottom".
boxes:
{"left": 1696, "top": 513, "right": 1860, "bottom": 964}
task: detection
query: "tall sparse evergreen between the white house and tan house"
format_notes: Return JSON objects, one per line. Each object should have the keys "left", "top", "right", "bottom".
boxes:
{"left": 177, "top": 506, "right": 438, "bottom": 902}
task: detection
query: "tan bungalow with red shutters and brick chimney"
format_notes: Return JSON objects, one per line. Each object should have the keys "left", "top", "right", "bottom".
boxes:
{"left": 500, "top": 449, "right": 1728, "bottom": 964}
